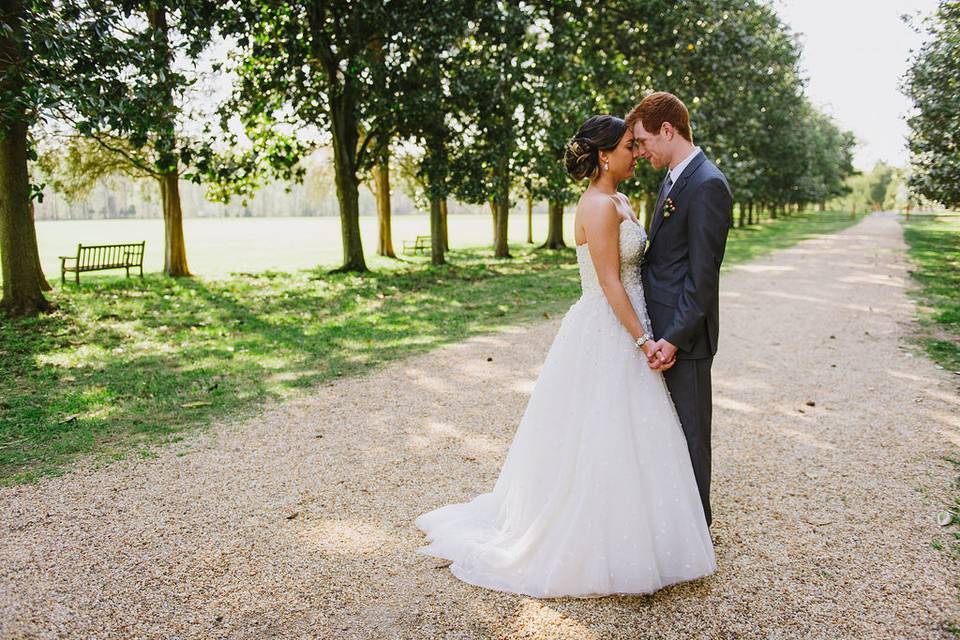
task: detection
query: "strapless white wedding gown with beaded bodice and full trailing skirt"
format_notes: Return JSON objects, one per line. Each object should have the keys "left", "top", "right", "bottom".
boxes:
{"left": 416, "top": 220, "right": 716, "bottom": 598}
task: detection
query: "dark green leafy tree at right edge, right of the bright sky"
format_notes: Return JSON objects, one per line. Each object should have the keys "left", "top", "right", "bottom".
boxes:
{"left": 903, "top": 0, "right": 960, "bottom": 208}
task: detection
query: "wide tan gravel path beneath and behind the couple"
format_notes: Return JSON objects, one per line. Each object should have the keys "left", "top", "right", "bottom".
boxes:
{"left": 0, "top": 215, "right": 960, "bottom": 640}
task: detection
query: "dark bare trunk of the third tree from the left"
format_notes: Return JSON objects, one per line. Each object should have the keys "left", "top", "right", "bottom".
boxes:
{"left": 330, "top": 93, "right": 367, "bottom": 272}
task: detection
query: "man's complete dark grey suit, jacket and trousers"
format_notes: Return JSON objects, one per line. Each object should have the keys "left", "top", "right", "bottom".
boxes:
{"left": 642, "top": 151, "right": 733, "bottom": 525}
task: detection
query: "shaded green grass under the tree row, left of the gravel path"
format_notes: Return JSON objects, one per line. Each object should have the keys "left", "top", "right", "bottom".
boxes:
{"left": 0, "top": 213, "right": 868, "bottom": 484}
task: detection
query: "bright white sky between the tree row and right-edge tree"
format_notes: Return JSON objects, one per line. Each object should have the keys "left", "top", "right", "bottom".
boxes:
{"left": 773, "top": 0, "right": 937, "bottom": 169}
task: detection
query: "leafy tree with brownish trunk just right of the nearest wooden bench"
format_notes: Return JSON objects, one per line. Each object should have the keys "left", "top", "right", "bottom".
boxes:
{"left": 36, "top": 0, "right": 228, "bottom": 276}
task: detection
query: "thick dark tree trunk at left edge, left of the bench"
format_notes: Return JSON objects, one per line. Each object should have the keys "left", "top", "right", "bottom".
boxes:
{"left": 0, "top": 120, "right": 56, "bottom": 316}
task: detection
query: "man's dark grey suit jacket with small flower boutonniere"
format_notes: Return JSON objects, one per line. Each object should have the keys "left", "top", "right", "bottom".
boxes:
{"left": 642, "top": 151, "right": 733, "bottom": 359}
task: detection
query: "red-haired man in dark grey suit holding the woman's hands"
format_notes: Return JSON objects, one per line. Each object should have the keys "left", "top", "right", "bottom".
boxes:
{"left": 626, "top": 92, "right": 733, "bottom": 525}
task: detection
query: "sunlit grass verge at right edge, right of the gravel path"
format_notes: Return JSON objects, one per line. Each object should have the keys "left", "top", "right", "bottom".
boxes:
{"left": 904, "top": 215, "right": 960, "bottom": 371}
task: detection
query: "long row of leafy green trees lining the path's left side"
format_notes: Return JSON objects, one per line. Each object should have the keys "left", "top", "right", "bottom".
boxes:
{"left": 0, "top": 0, "right": 854, "bottom": 313}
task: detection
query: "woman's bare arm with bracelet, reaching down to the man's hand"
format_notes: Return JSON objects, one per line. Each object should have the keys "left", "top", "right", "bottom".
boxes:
{"left": 583, "top": 202, "right": 653, "bottom": 357}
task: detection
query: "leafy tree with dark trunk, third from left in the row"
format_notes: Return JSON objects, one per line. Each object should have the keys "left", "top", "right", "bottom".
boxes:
{"left": 223, "top": 0, "right": 430, "bottom": 271}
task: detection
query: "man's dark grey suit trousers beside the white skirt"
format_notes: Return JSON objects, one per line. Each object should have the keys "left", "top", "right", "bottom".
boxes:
{"left": 663, "top": 357, "right": 713, "bottom": 526}
